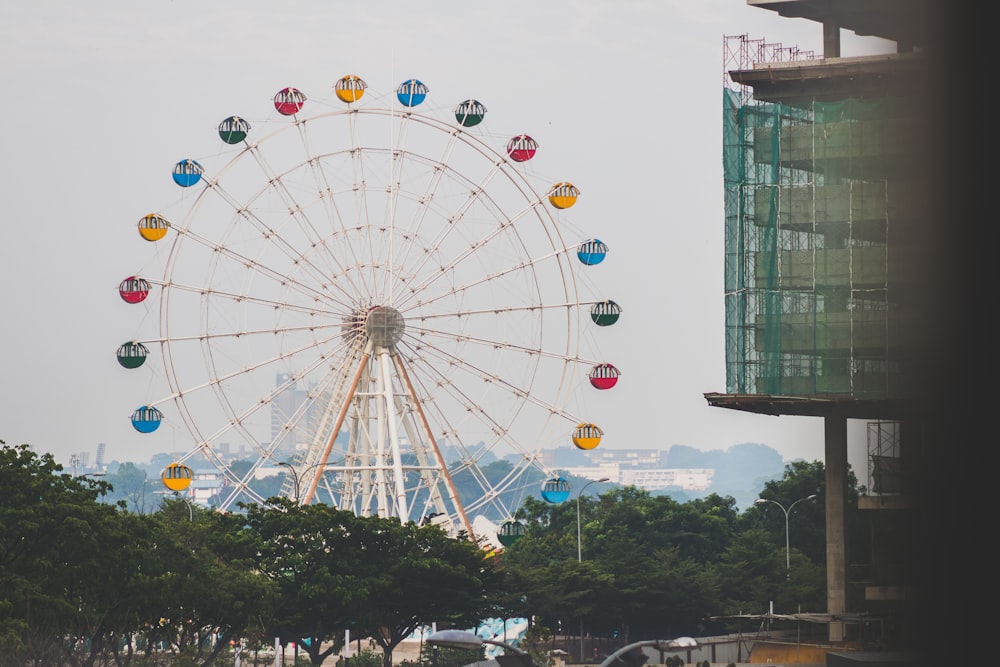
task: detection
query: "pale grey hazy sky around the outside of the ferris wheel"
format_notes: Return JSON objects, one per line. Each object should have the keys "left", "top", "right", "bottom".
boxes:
{"left": 0, "top": 0, "right": 886, "bottom": 481}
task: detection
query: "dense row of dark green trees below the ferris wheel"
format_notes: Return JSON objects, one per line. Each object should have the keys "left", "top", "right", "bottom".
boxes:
{"left": 0, "top": 441, "right": 864, "bottom": 667}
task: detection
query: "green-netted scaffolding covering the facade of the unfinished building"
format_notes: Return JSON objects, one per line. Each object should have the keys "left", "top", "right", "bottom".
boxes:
{"left": 723, "top": 35, "right": 916, "bottom": 399}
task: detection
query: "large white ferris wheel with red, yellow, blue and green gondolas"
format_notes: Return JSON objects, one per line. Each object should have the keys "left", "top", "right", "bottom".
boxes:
{"left": 117, "top": 75, "right": 621, "bottom": 536}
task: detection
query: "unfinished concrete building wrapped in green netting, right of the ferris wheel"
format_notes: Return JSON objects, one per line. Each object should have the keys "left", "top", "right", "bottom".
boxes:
{"left": 705, "top": 0, "right": 980, "bottom": 664}
